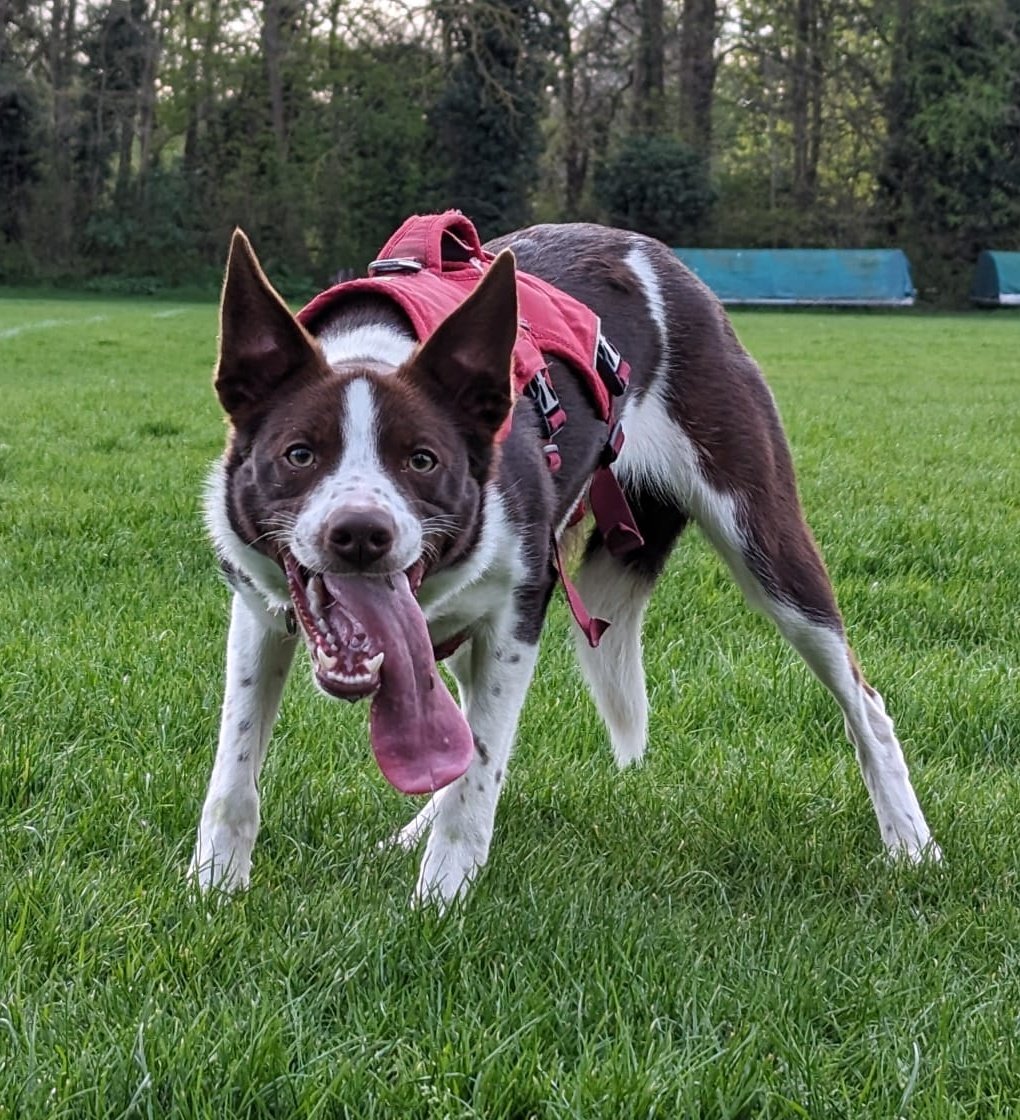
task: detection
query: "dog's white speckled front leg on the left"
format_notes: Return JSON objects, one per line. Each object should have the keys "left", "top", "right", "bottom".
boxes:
{"left": 189, "top": 591, "right": 297, "bottom": 890}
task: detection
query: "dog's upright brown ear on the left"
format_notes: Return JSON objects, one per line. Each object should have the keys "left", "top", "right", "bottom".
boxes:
{"left": 214, "top": 230, "right": 317, "bottom": 420}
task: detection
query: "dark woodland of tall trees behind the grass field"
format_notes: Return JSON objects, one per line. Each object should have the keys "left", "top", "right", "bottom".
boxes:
{"left": 0, "top": 0, "right": 1020, "bottom": 304}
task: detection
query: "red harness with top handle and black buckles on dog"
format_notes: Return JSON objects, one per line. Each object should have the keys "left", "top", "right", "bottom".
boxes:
{"left": 298, "top": 211, "right": 644, "bottom": 646}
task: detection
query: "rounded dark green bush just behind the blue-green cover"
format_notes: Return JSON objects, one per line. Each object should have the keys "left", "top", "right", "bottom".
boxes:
{"left": 595, "top": 134, "right": 714, "bottom": 245}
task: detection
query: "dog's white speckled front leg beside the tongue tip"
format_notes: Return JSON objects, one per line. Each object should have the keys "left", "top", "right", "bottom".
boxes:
{"left": 412, "top": 619, "right": 539, "bottom": 909}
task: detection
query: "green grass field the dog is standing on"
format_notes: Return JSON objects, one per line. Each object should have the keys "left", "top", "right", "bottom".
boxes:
{"left": 0, "top": 299, "right": 1020, "bottom": 1120}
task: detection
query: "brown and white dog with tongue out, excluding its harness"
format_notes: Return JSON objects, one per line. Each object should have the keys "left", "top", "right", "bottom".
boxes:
{"left": 191, "top": 225, "right": 938, "bottom": 906}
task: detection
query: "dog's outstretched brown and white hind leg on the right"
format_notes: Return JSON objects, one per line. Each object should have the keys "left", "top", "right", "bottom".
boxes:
{"left": 610, "top": 367, "right": 938, "bottom": 860}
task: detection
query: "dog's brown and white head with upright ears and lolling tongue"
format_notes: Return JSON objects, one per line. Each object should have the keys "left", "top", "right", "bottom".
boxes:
{"left": 213, "top": 231, "right": 517, "bottom": 792}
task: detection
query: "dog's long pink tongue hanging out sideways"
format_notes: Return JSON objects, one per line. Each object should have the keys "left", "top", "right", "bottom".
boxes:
{"left": 322, "top": 572, "right": 475, "bottom": 793}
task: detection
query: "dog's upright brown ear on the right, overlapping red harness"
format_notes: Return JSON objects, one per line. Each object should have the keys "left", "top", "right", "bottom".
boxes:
{"left": 411, "top": 249, "right": 517, "bottom": 442}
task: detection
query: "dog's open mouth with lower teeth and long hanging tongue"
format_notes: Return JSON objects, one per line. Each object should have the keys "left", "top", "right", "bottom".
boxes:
{"left": 284, "top": 553, "right": 475, "bottom": 793}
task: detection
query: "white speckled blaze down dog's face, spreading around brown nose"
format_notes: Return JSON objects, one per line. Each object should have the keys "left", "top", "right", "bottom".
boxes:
{"left": 292, "top": 377, "right": 422, "bottom": 571}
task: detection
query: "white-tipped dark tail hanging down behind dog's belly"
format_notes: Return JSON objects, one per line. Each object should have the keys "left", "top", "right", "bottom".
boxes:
{"left": 574, "top": 491, "right": 687, "bottom": 767}
